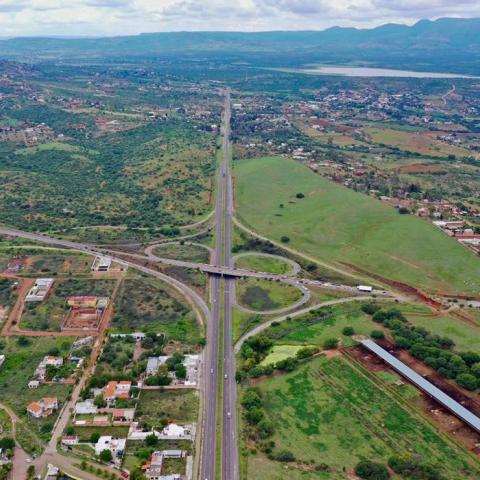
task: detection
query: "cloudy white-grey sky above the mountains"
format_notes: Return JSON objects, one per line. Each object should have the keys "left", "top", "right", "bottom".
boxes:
{"left": 0, "top": 0, "right": 480, "bottom": 37}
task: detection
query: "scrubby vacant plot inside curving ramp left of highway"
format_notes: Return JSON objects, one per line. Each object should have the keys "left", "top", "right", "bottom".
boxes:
{"left": 111, "top": 277, "right": 202, "bottom": 345}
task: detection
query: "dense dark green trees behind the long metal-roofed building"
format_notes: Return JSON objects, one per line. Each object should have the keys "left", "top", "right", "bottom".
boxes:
{"left": 362, "top": 306, "right": 480, "bottom": 391}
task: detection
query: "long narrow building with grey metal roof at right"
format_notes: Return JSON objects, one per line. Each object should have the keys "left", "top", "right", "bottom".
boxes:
{"left": 361, "top": 340, "right": 480, "bottom": 433}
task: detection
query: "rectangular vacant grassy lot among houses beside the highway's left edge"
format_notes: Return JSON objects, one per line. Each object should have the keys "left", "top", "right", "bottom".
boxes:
{"left": 137, "top": 390, "right": 199, "bottom": 429}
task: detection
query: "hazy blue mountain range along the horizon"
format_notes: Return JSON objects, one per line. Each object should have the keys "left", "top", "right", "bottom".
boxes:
{"left": 0, "top": 18, "right": 480, "bottom": 74}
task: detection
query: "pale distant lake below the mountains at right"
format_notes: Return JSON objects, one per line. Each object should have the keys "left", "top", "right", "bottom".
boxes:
{"left": 297, "top": 66, "right": 479, "bottom": 78}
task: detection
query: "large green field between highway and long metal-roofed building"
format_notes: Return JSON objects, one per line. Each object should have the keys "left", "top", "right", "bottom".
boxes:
{"left": 244, "top": 357, "right": 480, "bottom": 480}
